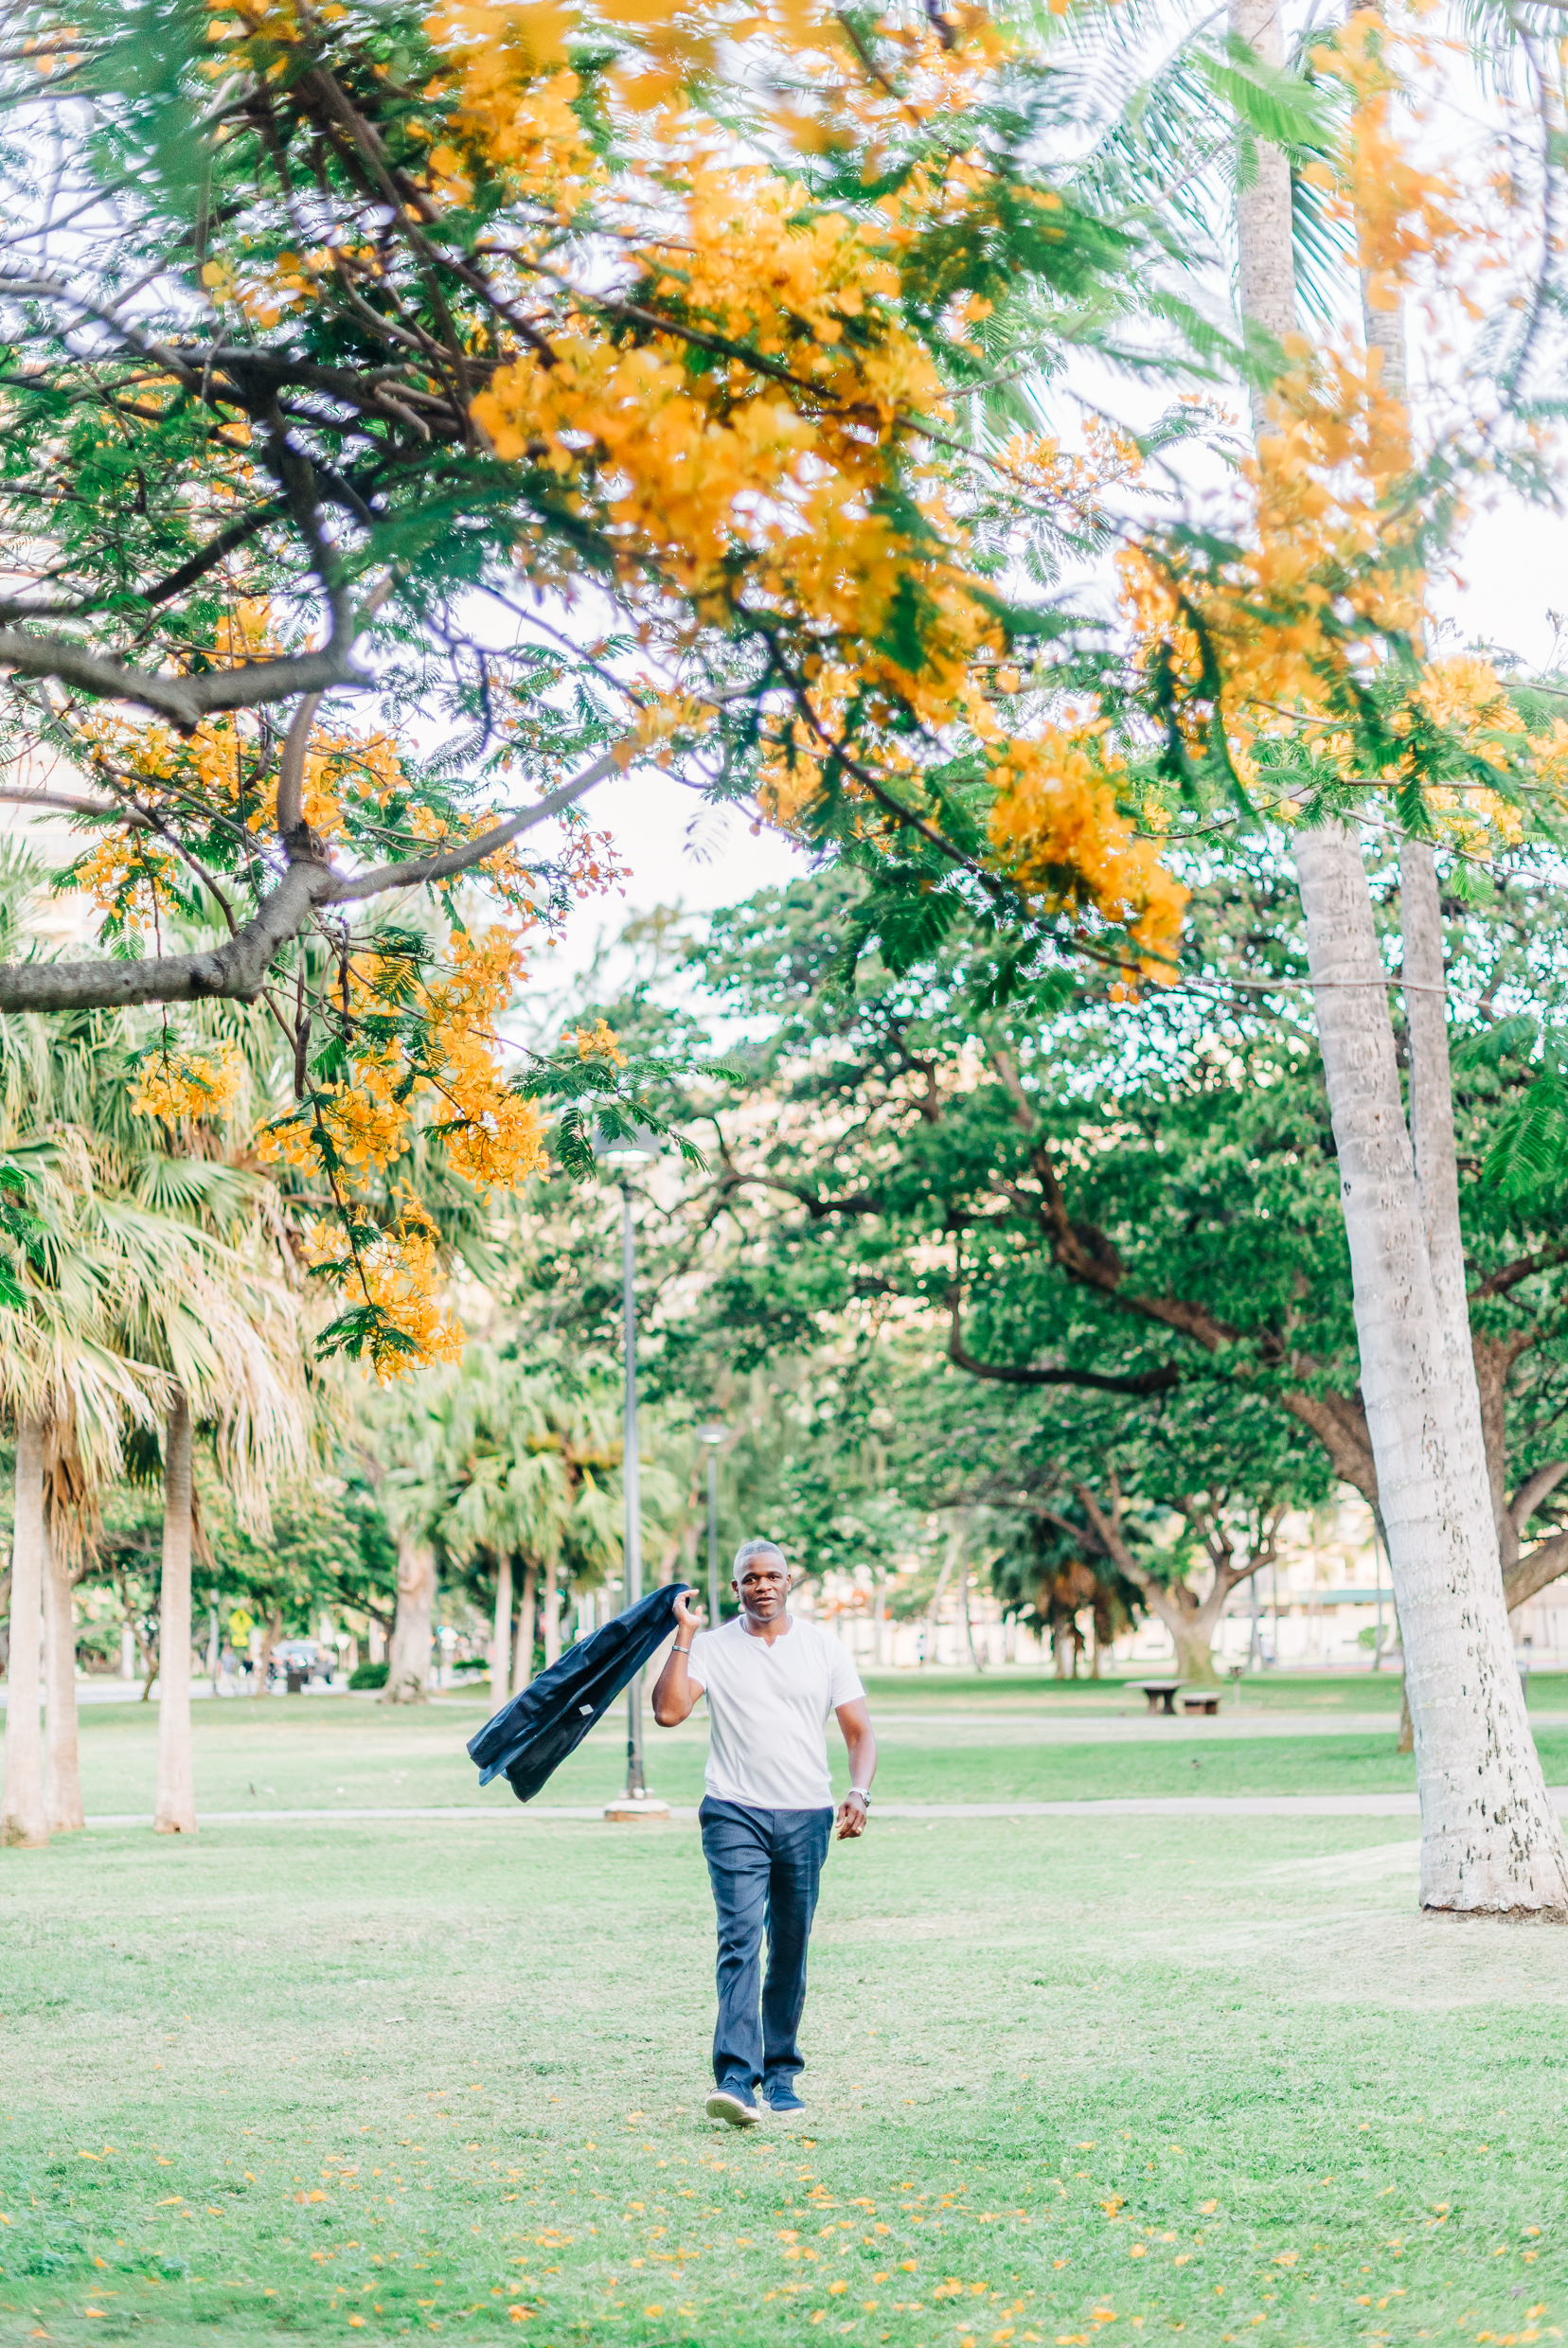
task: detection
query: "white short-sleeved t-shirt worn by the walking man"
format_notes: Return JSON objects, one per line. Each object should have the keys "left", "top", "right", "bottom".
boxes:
{"left": 686, "top": 1615, "right": 866, "bottom": 1810}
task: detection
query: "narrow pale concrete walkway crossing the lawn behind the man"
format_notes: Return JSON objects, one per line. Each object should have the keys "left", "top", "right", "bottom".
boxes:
{"left": 87, "top": 1785, "right": 1568, "bottom": 1826}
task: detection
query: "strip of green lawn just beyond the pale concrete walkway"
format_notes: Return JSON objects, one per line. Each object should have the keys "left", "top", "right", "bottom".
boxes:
{"left": 67, "top": 1696, "right": 1568, "bottom": 1815}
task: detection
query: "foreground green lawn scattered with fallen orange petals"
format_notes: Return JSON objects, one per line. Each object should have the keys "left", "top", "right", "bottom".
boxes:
{"left": 0, "top": 1702, "right": 1568, "bottom": 2348}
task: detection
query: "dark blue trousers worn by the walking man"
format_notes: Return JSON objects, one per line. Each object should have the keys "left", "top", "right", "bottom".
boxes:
{"left": 697, "top": 1794, "right": 833, "bottom": 2090}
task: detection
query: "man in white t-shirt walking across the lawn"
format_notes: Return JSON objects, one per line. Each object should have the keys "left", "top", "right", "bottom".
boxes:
{"left": 652, "top": 1540, "right": 876, "bottom": 2127}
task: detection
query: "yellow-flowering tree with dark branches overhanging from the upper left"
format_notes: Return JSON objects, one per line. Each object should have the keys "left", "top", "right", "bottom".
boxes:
{"left": 0, "top": 0, "right": 1230, "bottom": 1369}
